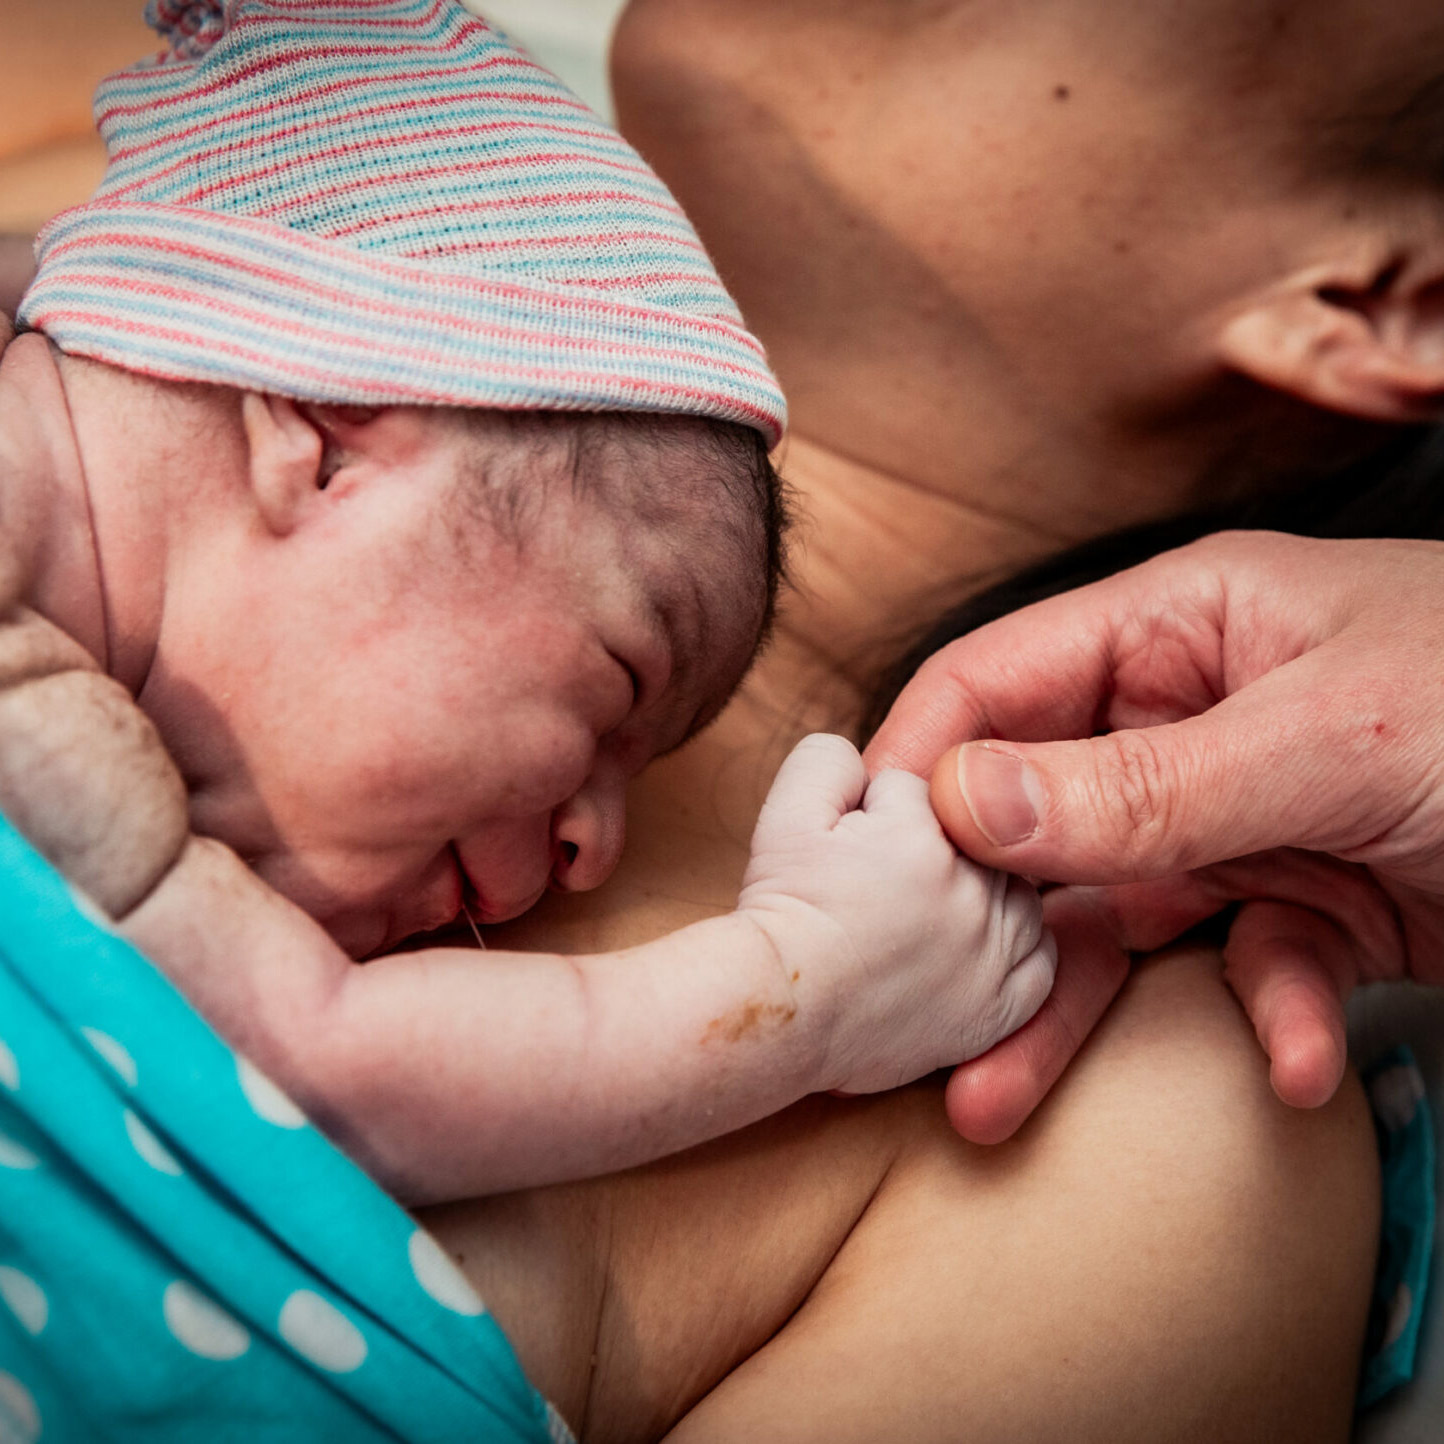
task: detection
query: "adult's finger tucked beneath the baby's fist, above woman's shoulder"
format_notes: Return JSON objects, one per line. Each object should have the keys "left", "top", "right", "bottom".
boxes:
{"left": 946, "top": 891, "right": 1128, "bottom": 1144}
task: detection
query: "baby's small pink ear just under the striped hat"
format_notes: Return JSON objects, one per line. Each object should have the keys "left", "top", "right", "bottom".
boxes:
{"left": 241, "top": 391, "right": 394, "bottom": 536}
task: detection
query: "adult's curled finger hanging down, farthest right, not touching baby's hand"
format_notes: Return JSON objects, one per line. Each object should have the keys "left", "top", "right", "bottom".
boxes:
{"left": 1223, "top": 901, "right": 1357, "bottom": 1108}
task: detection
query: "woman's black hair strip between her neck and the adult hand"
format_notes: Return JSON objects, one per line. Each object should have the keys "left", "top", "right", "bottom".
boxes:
{"left": 861, "top": 426, "right": 1444, "bottom": 738}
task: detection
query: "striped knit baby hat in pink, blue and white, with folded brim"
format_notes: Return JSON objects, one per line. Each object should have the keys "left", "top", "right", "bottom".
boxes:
{"left": 20, "top": 0, "right": 786, "bottom": 442}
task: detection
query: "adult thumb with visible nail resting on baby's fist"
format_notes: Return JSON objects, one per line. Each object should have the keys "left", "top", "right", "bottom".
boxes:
{"left": 931, "top": 669, "right": 1386, "bottom": 884}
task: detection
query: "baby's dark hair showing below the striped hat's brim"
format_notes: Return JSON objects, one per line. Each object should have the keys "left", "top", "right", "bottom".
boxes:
{"left": 453, "top": 410, "right": 788, "bottom": 635}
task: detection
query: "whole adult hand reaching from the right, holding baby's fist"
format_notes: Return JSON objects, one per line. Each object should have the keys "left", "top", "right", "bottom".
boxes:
{"left": 868, "top": 533, "right": 1444, "bottom": 1141}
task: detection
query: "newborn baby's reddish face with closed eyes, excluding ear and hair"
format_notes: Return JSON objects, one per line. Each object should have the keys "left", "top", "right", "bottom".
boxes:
{"left": 146, "top": 421, "right": 764, "bottom": 956}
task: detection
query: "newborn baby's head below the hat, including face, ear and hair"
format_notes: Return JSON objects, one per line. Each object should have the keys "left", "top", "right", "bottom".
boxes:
{"left": 62, "top": 378, "right": 780, "bottom": 954}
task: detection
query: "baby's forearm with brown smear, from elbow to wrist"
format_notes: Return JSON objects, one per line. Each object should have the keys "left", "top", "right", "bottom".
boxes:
{"left": 314, "top": 913, "right": 814, "bottom": 1201}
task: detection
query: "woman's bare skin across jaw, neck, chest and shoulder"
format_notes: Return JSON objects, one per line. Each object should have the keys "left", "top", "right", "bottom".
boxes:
{"left": 407, "top": 0, "right": 1424, "bottom": 1441}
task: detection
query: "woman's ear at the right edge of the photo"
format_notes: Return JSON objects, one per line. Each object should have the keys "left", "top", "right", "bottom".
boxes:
{"left": 1219, "top": 227, "right": 1444, "bottom": 422}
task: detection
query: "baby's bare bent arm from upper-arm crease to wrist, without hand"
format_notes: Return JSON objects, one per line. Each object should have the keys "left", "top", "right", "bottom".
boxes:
{"left": 124, "top": 842, "right": 814, "bottom": 1201}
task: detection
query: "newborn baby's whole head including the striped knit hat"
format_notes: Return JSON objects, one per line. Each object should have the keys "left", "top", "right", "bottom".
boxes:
{"left": 20, "top": 0, "right": 784, "bottom": 953}
